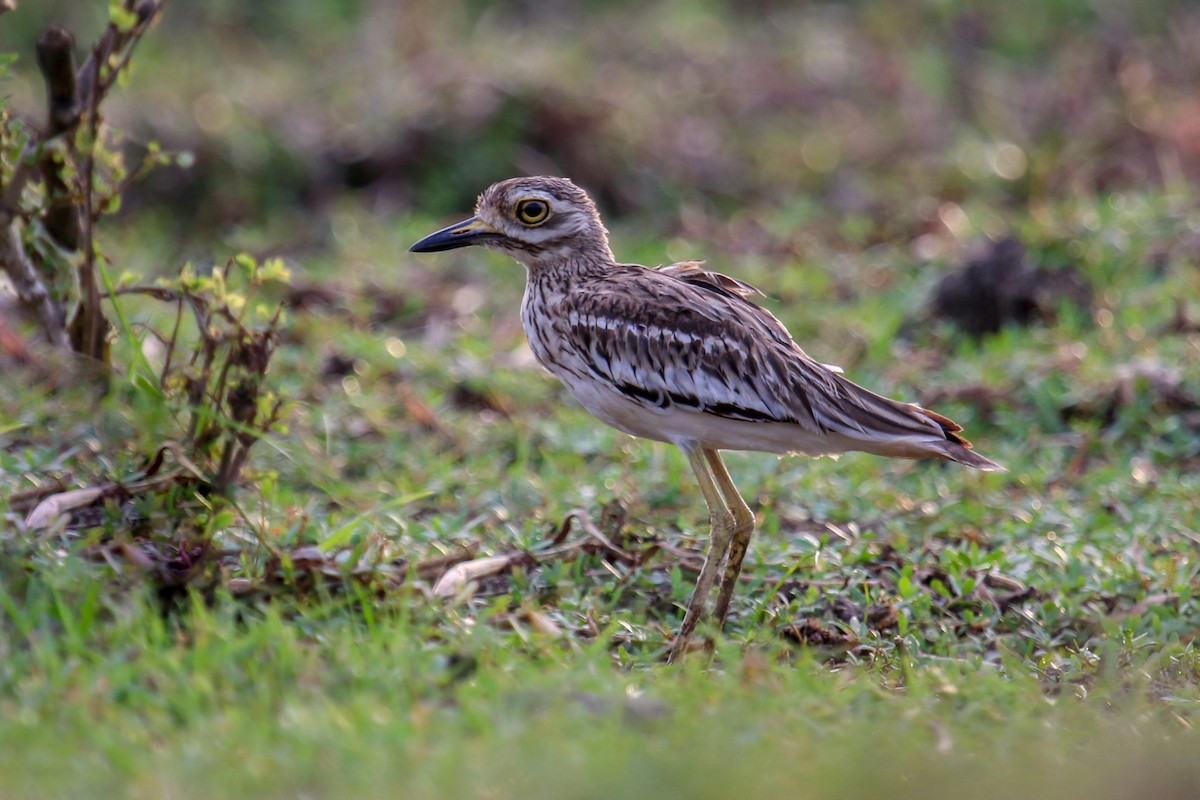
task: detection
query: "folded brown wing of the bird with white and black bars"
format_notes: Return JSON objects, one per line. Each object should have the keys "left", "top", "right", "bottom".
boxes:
{"left": 562, "top": 263, "right": 956, "bottom": 441}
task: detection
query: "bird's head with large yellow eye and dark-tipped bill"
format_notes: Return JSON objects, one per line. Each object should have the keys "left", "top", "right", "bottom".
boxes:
{"left": 408, "top": 178, "right": 612, "bottom": 269}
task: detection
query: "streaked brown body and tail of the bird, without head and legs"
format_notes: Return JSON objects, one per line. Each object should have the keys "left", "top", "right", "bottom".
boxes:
{"left": 523, "top": 261, "right": 998, "bottom": 469}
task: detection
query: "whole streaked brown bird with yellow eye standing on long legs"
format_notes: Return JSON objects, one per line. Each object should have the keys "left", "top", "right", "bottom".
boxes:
{"left": 409, "top": 176, "right": 1003, "bottom": 662}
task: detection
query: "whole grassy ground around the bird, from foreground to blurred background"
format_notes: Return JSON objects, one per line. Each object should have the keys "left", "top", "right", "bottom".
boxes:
{"left": 0, "top": 0, "right": 1200, "bottom": 800}
